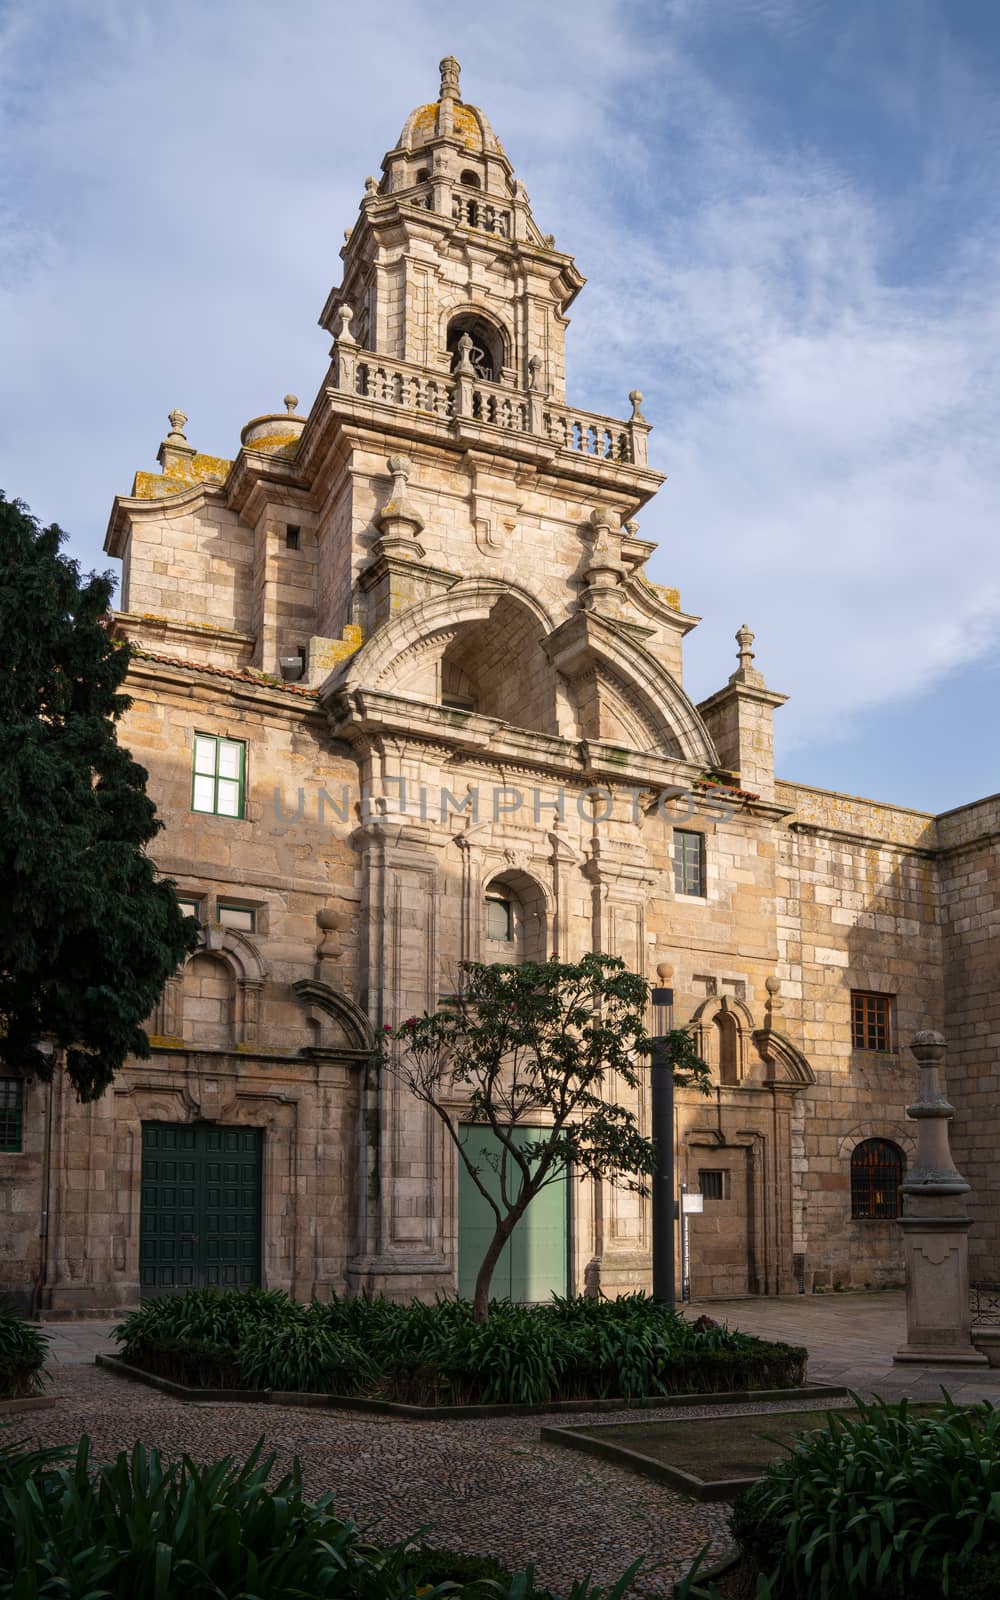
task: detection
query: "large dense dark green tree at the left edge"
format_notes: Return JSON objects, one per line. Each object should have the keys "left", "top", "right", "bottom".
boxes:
{"left": 0, "top": 493, "right": 197, "bottom": 1099}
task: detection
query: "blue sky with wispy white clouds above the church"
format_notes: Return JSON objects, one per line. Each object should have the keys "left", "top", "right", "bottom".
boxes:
{"left": 0, "top": 0, "right": 1000, "bottom": 810}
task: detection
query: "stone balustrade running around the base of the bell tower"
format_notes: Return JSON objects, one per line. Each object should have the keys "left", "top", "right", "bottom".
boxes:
{"left": 333, "top": 334, "right": 650, "bottom": 467}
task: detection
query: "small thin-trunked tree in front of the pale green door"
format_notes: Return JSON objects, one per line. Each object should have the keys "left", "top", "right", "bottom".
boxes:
{"left": 382, "top": 955, "right": 709, "bottom": 1322}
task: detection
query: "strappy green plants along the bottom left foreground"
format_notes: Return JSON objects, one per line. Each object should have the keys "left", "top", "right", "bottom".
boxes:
{"left": 0, "top": 1438, "right": 635, "bottom": 1600}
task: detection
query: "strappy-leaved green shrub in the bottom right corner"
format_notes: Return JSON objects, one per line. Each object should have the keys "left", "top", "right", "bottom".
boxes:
{"left": 733, "top": 1397, "right": 1000, "bottom": 1600}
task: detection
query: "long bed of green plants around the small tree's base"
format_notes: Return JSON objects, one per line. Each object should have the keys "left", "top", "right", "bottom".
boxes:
{"left": 115, "top": 1290, "right": 805, "bottom": 1405}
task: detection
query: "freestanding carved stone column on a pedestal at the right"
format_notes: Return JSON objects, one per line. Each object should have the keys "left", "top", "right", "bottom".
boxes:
{"left": 894, "top": 1030, "right": 987, "bottom": 1366}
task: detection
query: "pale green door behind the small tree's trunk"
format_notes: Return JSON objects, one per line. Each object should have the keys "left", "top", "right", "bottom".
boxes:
{"left": 458, "top": 1123, "right": 570, "bottom": 1301}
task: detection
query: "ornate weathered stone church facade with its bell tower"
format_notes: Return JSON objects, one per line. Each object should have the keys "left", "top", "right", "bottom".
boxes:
{"left": 0, "top": 58, "right": 1000, "bottom": 1315}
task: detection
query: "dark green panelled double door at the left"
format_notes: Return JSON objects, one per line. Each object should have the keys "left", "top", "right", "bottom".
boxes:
{"left": 139, "top": 1122, "right": 262, "bottom": 1298}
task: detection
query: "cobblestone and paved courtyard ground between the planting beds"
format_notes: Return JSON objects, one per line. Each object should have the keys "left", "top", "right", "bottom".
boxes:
{"left": 18, "top": 1294, "right": 1000, "bottom": 1595}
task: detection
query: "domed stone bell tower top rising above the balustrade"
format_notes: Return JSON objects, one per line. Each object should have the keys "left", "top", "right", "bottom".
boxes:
{"left": 320, "top": 56, "right": 584, "bottom": 402}
